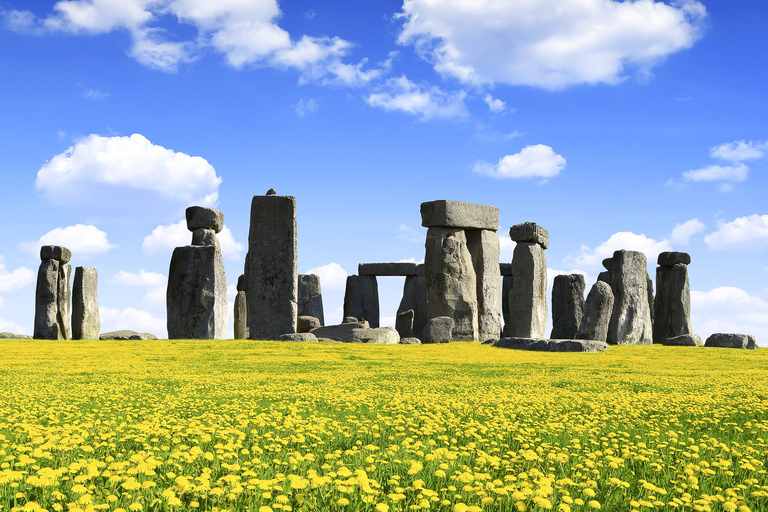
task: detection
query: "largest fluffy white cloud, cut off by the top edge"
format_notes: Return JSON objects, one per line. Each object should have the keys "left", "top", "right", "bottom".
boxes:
{"left": 398, "top": 0, "right": 706, "bottom": 89}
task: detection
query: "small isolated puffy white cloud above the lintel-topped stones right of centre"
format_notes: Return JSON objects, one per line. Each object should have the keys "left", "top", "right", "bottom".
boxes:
{"left": 472, "top": 144, "right": 565, "bottom": 180}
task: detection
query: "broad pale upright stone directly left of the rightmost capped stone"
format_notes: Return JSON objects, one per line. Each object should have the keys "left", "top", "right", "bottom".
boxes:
{"left": 607, "top": 250, "right": 653, "bottom": 345}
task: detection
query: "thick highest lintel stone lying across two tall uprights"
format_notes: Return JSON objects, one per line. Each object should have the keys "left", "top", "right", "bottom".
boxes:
{"left": 421, "top": 200, "right": 499, "bottom": 231}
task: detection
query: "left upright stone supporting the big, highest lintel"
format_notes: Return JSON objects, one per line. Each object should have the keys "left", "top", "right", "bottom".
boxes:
{"left": 424, "top": 227, "right": 479, "bottom": 340}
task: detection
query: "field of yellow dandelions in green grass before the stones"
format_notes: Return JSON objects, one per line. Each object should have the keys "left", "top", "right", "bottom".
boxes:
{"left": 0, "top": 340, "right": 768, "bottom": 512}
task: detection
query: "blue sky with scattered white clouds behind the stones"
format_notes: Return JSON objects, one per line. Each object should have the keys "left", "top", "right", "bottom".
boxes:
{"left": 0, "top": 0, "right": 768, "bottom": 345}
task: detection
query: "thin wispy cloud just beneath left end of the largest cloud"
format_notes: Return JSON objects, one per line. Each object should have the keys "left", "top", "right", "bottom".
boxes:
{"left": 365, "top": 75, "right": 467, "bottom": 121}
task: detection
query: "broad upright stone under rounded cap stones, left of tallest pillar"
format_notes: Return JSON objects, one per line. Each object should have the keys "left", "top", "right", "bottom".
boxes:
{"left": 166, "top": 245, "right": 226, "bottom": 339}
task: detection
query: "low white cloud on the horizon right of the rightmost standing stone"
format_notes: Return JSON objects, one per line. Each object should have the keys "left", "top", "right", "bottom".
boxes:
{"left": 691, "top": 286, "right": 768, "bottom": 346}
